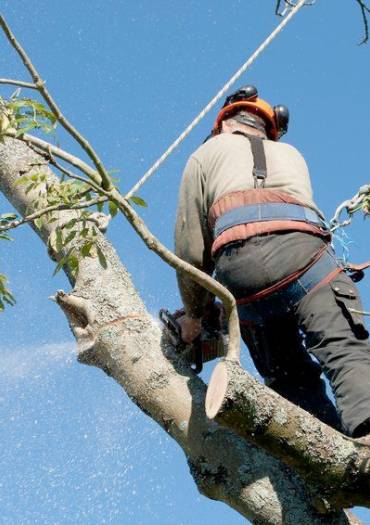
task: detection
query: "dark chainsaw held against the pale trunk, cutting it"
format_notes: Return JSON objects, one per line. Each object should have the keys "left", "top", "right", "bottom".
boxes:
{"left": 159, "top": 303, "right": 229, "bottom": 374}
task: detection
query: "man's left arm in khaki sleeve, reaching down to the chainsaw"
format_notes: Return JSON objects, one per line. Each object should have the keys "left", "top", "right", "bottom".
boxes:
{"left": 175, "top": 157, "right": 214, "bottom": 319}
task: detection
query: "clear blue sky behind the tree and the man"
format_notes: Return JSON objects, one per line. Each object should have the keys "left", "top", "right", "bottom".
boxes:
{"left": 0, "top": 0, "right": 370, "bottom": 525}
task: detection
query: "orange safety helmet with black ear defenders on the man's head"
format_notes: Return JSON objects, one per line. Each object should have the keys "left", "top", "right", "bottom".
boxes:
{"left": 212, "top": 86, "right": 289, "bottom": 140}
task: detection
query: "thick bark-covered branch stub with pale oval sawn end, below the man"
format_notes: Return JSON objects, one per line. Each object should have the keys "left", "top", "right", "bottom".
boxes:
{"left": 206, "top": 359, "right": 370, "bottom": 508}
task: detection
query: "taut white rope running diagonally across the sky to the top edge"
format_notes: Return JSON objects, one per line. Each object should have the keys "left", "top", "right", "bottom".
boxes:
{"left": 125, "top": 0, "right": 306, "bottom": 199}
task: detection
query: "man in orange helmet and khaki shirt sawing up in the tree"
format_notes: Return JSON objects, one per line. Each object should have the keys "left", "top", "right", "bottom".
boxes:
{"left": 176, "top": 86, "right": 370, "bottom": 437}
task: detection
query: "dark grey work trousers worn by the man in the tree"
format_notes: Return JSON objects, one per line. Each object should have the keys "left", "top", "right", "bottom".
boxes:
{"left": 216, "top": 233, "right": 370, "bottom": 436}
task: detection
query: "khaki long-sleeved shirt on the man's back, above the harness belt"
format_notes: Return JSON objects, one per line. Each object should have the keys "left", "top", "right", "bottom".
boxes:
{"left": 175, "top": 133, "right": 322, "bottom": 317}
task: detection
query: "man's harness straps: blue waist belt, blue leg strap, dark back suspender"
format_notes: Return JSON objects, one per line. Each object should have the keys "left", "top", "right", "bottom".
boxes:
{"left": 214, "top": 131, "right": 344, "bottom": 324}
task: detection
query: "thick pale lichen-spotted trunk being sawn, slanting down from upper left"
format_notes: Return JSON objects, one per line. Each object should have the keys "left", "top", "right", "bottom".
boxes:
{"left": 0, "top": 139, "right": 360, "bottom": 525}
